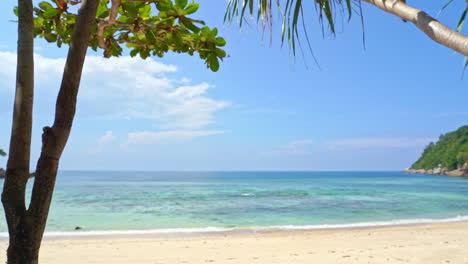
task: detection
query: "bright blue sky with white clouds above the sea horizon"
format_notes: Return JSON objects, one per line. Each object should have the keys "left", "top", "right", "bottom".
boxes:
{"left": 0, "top": 0, "right": 468, "bottom": 171}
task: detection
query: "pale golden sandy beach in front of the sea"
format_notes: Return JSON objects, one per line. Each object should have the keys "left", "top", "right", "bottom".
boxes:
{"left": 0, "top": 222, "right": 468, "bottom": 264}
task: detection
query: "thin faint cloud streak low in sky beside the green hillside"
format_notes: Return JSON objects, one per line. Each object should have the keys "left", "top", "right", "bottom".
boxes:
{"left": 326, "top": 137, "right": 434, "bottom": 150}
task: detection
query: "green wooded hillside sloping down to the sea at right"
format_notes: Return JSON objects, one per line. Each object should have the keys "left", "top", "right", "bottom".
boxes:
{"left": 411, "top": 126, "right": 468, "bottom": 170}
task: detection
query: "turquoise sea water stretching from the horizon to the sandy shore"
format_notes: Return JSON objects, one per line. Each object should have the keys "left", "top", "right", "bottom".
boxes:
{"left": 0, "top": 171, "right": 468, "bottom": 235}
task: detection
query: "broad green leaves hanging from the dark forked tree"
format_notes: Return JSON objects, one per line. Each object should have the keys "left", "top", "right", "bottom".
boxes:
{"left": 25, "top": 0, "right": 226, "bottom": 71}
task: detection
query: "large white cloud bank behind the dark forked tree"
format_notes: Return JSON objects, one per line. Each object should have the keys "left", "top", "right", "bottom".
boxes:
{"left": 0, "top": 52, "right": 230, "bottom": 148}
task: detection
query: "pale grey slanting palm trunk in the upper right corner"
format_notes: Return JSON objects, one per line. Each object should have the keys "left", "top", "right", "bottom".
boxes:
{"left": 363, "top": 0, "right": 468, "bottom": 56}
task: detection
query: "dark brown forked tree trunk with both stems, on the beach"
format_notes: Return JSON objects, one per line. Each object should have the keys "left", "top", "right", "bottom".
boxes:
{"left": 2, "top": 0, "right": 99, "bottom": 264}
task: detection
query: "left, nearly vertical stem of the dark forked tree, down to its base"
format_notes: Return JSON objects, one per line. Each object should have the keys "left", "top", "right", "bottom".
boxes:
{"left": 2, "top": 0, "right": 37, "bottom": 264}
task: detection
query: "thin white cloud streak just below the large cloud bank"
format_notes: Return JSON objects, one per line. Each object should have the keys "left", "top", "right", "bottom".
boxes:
{"left": 122, "top": 130, "right": 225, "bottom": 148}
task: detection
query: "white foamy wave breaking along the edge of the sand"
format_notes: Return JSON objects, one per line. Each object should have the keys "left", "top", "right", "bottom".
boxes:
{"left": 0, "top": 215, "right": 468, "bottom": 238}
